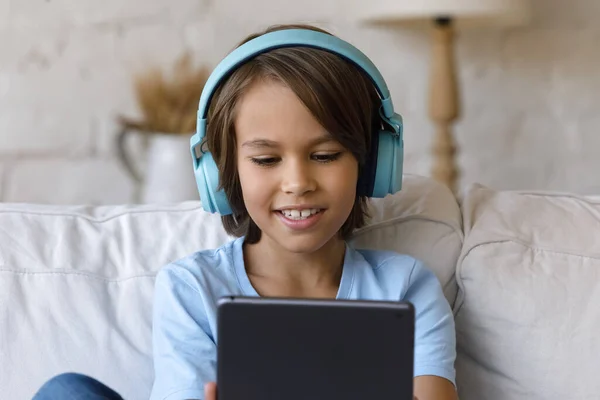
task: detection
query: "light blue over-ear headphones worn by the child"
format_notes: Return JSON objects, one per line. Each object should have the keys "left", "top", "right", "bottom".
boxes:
{"left": 190, "top": 29, "right": 404, "bottom": 215}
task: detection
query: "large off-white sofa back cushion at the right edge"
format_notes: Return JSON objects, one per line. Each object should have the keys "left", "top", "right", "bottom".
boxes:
{"left": 455, "top": 186, "right": 600, "bottom": 400}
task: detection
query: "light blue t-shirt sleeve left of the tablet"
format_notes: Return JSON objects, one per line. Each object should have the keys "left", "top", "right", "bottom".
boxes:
{"left": 150, "top": 266, "right": 217, "bottom": 400}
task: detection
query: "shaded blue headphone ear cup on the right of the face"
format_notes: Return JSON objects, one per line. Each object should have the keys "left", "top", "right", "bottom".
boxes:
{"left": 372, "top": 131, "right": 404, "bottom": 198}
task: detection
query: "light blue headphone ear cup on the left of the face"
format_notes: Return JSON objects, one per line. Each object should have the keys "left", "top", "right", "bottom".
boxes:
{"left": 194, "top": 152, "right": 232, "bottom": 215}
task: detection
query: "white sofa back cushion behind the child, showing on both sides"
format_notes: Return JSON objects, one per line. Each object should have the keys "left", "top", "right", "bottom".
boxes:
{"left": 0, "top": 176, "right": 462, "bottom": 399}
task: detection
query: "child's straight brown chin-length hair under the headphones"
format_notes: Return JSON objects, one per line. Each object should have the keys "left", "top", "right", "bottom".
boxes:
{"left": 204, "top": 25, "right": 381, "bottom": 243}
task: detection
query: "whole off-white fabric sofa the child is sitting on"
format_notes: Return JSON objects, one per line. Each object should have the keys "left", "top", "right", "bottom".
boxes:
{"left": 0, "top": 175, "right": 600, "bottom": 400}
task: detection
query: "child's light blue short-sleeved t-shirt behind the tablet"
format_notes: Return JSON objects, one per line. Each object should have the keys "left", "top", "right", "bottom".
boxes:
{"left": 150, "top": 238, "right": 456, "bottom": 400}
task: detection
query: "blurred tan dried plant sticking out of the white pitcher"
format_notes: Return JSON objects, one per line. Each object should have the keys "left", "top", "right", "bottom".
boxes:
{"left": 119, "top": 53, "right": 209, "bottom": 134}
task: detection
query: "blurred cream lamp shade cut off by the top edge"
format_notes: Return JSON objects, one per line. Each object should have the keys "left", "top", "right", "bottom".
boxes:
{"left": 352, "top": 0, "right": 530, "bottom": 28}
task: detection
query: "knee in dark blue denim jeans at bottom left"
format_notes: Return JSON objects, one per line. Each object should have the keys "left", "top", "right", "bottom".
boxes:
{"left": 33, "top": 373, "right": 123, "bottom": 400}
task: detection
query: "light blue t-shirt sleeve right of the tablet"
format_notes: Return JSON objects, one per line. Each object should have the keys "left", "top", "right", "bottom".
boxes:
{"left": 404, "top": 261, "right": 456, "bottom": 384}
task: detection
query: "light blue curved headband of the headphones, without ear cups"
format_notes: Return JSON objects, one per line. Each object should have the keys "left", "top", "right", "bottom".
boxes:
{"left": 197, "top": 29, "right": 394, "bottom": 139}
